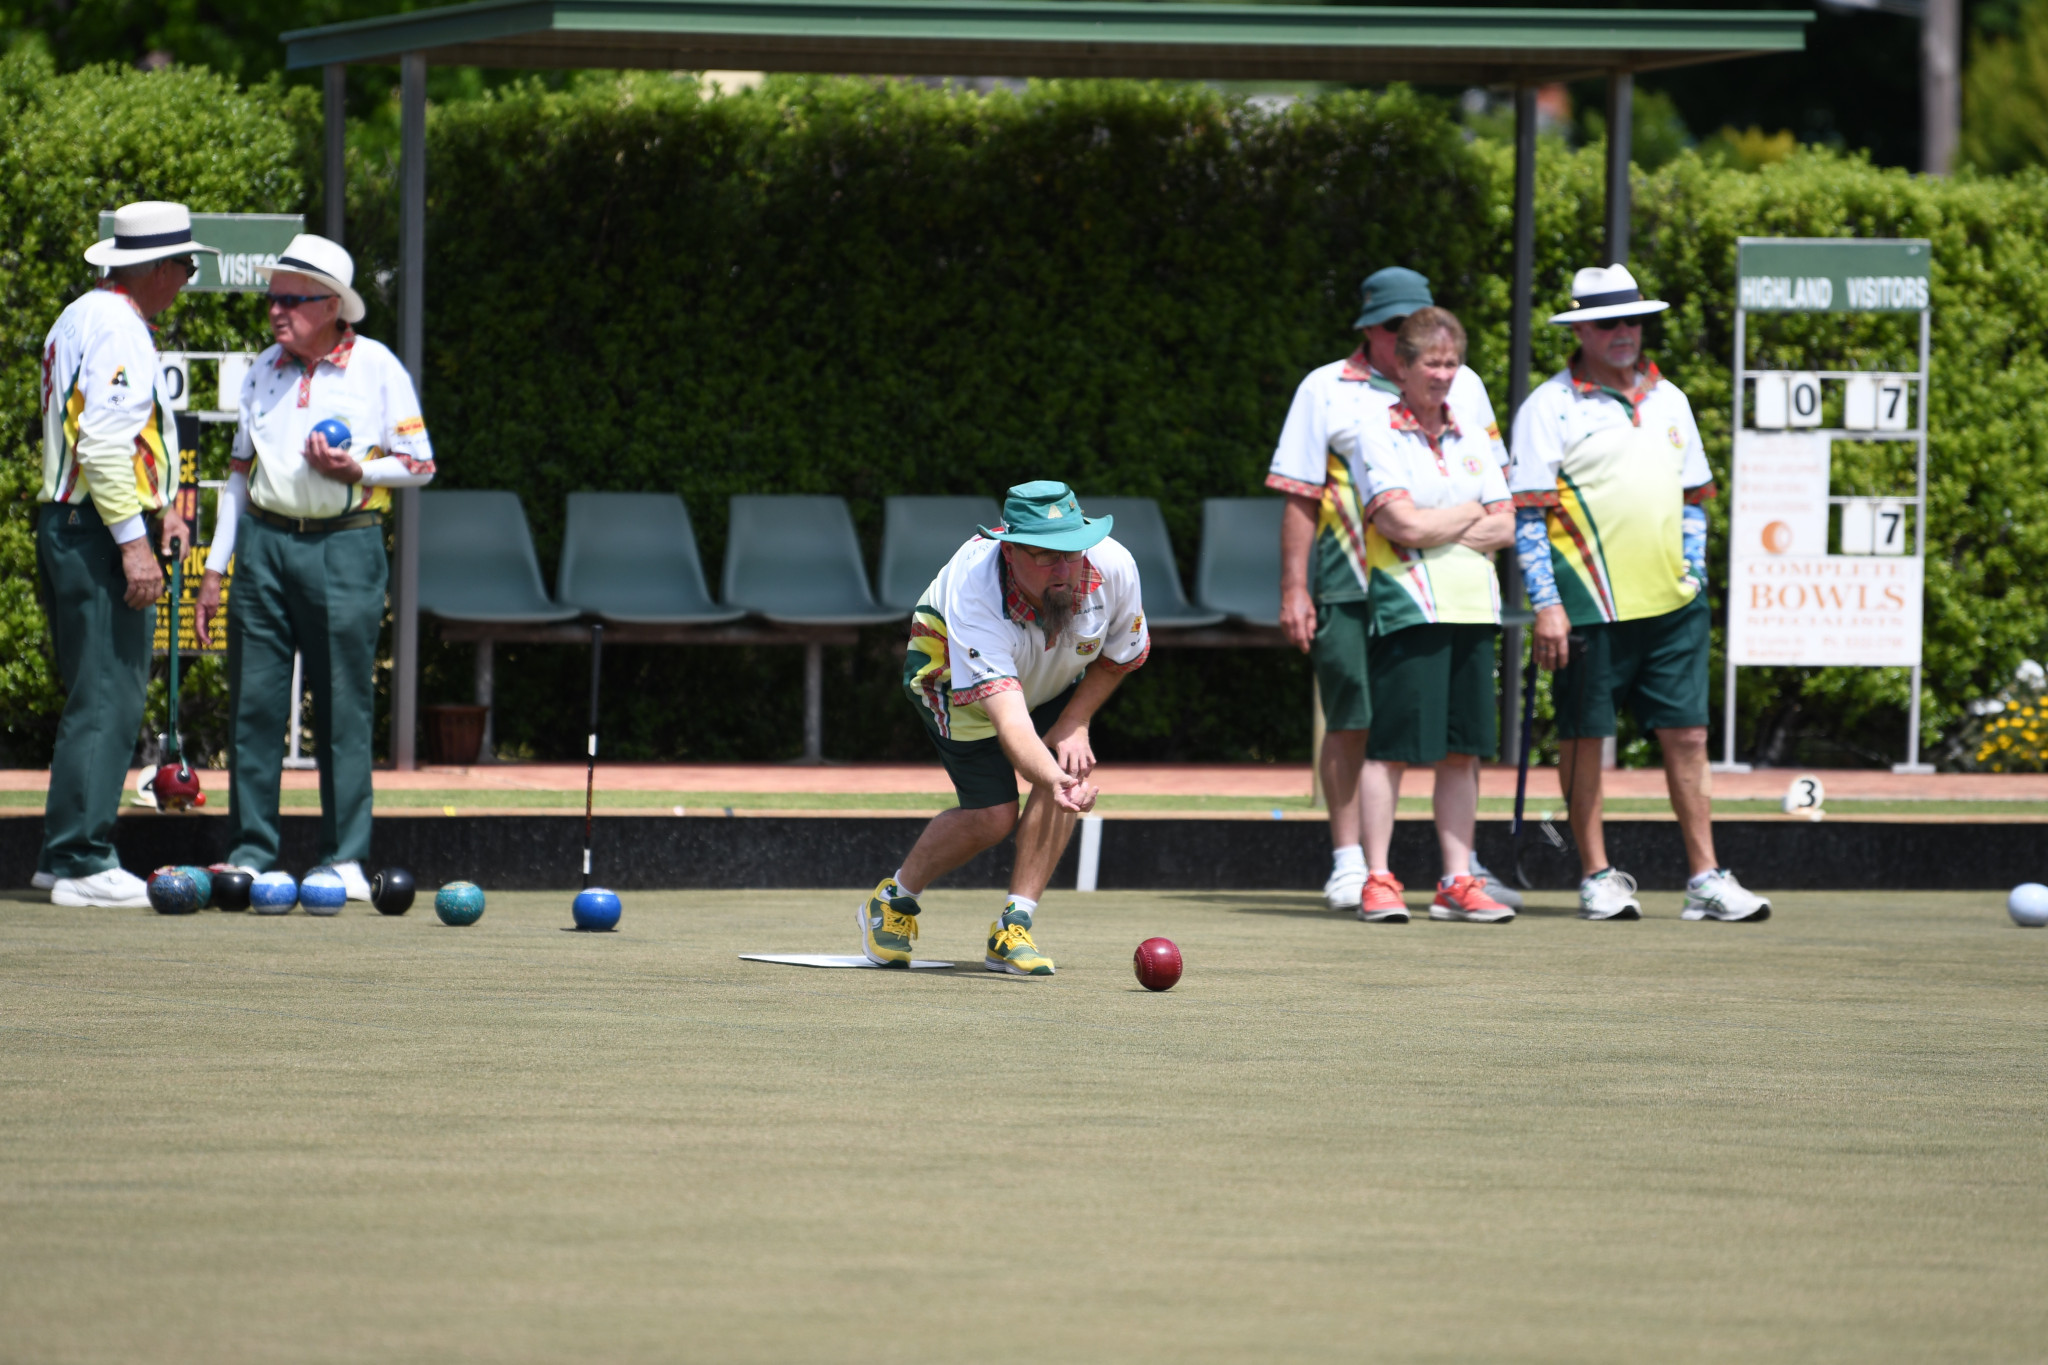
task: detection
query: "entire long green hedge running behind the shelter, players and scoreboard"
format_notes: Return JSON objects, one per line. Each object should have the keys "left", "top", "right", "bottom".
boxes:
{"left": 0, "top": 57, "right": 2048, "bottom": 761}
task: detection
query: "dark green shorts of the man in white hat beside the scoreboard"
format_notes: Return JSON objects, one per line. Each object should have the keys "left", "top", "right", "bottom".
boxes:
{"left": 1550, "top": 593, "right": 1708, "bottom": 739}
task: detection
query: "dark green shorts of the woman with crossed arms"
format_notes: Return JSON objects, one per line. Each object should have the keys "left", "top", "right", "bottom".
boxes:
{"left": 1366, "top": 624, "right": 1501, "bottom": 763}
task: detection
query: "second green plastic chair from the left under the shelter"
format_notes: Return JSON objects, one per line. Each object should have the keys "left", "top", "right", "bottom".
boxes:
{"left": 555, "top": 493, "right": 745, "bottom": 626}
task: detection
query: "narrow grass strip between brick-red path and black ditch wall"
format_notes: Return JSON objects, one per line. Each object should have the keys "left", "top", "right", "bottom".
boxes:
{"left": 16, "top": 780, "right": 2048, "bottom": 821}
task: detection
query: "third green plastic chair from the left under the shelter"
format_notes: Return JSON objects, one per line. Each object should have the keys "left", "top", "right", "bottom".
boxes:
{"left": 725, "top": 493, "right": 905, "bottom": 626}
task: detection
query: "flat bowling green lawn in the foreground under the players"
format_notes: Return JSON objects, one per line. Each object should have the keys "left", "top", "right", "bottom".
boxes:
{"left": 0, "top": 892, "right": 2048, "bottom": 1363}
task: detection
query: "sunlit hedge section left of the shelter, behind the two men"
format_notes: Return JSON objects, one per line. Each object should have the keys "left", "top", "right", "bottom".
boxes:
{"left": 0, "top": 45, "right": 319, "bottom": 763}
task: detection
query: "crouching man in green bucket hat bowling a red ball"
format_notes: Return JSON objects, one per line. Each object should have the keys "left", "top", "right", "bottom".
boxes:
{"left": 860, "top": 479, "right": 1151, "bottom": 976}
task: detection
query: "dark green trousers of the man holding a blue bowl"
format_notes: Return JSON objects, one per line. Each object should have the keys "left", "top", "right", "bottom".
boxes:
{"left": 227, "top": 516, "right": 391, "bottom": 872}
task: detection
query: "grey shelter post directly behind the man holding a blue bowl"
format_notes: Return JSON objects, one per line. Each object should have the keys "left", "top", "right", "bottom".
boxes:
{"left": 391, "top": 51, "right": 426, "bottom": 772}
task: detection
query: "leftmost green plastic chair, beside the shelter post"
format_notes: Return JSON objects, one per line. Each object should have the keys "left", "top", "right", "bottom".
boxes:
{"left": 420, "top": 489, "right": 578, "bottom": 626}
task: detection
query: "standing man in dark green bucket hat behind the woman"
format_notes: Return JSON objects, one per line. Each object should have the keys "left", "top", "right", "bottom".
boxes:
{"left": 1266, "top": 266, "right": 1520, "bottom": 913}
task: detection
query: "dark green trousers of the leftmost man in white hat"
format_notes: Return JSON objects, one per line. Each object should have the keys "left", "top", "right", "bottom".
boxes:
{"left": 35, "top": 501, "right": 156, "bottom": 878}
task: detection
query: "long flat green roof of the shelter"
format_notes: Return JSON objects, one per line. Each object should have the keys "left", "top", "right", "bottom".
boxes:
{"left": 283, "top": 0, "right": 1812, "bottom": 84}
